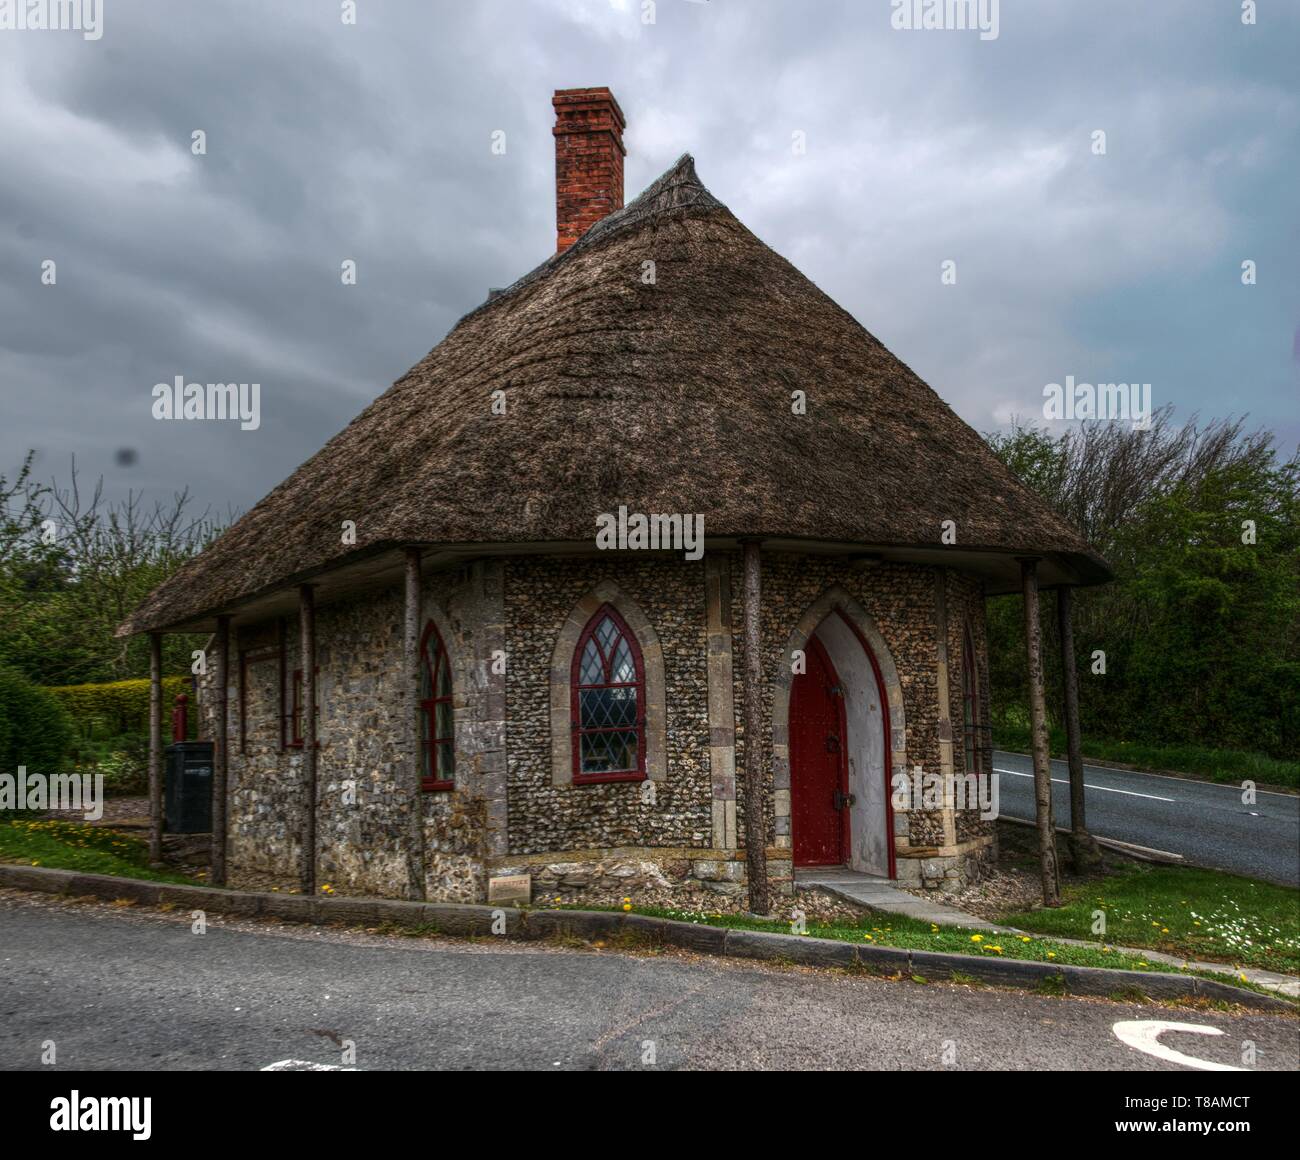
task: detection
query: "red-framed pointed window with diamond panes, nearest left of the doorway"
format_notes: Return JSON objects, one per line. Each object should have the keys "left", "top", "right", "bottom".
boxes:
{"left": 571, "top": 605, "right": 646, "bottom": 783}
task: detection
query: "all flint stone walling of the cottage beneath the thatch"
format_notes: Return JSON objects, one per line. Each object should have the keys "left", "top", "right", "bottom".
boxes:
{"left": 210, "top": 553, "right": 991, "bottom": 901}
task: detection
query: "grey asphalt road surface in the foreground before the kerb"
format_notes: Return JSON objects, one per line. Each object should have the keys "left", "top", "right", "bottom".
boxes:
{"left": 0, "top": 891, "right": 1300, "bottom": 1070}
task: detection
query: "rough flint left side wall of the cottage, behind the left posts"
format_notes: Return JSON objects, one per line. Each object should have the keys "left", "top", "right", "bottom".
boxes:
{"left": 218, "top": 566, "right": 504, "bottom": 901}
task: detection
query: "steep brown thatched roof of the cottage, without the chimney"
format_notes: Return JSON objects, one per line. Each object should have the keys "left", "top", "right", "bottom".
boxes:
{"left": 122, "top": 156, "right": 1109, "bottom": 632}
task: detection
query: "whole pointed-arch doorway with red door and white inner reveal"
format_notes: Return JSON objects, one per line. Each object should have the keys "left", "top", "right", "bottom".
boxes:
{"left": 787, "top": 603, "right": 898, "bottom": 878}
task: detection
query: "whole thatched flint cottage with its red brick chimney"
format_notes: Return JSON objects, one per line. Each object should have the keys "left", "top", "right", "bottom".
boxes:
{"left": 122, "top": 88, "right": 1109, "bottom": 909}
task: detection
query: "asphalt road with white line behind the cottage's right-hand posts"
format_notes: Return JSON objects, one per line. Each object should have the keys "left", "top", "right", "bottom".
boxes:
{"left": 993, "top": 752, "right": 1300, "bottom": 886}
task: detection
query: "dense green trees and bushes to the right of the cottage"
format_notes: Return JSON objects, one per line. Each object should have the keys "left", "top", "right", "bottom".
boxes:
{"left": 985, "top": 408, "right": 1300, "bottom": 757}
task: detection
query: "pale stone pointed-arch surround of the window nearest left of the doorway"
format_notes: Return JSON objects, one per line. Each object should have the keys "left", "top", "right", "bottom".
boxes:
{"left": 550, "top": 580, "right": 668, "bottom": 785}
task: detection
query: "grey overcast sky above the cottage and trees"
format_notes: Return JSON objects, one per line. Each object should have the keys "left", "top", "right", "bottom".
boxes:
{"left": 0, "top": 0, "right": 1300, "bottom": 512}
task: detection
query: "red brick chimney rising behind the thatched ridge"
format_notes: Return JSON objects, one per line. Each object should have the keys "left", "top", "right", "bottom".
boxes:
{"left": 551, "top": 88, "right": 628, "bottom": 254}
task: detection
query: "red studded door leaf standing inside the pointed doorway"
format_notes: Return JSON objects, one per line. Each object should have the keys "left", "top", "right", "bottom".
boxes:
{"left": 790, "top": 636, "right": 849, "bottom": 866}
